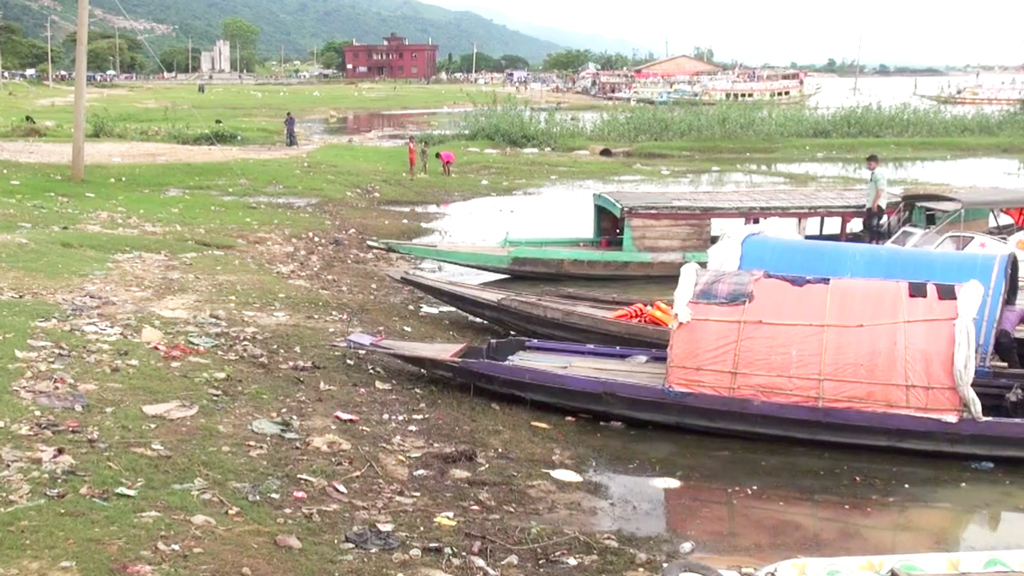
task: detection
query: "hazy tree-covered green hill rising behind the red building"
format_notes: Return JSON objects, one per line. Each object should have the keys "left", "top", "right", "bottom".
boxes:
{"left": 0, "top": 0, "right": 560, "bottom": 63}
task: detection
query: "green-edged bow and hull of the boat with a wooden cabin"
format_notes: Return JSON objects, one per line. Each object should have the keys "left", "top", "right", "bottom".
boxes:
{"left": 370, "top": 241, "right": 687, "bottom": 280}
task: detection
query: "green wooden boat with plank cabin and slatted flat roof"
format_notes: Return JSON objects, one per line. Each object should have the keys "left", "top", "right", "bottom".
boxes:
{"left": 368, "top": 190, "right": 864, "bottom": 279}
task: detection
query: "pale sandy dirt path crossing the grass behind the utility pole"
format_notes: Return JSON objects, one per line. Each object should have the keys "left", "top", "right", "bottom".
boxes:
{"left": 0, "top": 141, "right": 312, "bottom": 164}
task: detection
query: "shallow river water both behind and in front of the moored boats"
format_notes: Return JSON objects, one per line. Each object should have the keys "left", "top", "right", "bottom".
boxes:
{"left": 401, "top": 158, "right": 1024, "bottom": 567}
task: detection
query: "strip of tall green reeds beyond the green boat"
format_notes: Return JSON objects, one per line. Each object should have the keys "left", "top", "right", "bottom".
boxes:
{"left": 460, "top": 102, "right": 1024, "bottom": 148}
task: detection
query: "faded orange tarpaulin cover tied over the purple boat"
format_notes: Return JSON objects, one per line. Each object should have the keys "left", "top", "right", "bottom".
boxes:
{"left": 668, "top": 278, "right": 961, "bottom": 419}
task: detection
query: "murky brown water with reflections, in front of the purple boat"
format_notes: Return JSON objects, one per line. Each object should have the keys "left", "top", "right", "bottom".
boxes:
{"left": 585, "top": 430, "right": 1024, "bottom": 564}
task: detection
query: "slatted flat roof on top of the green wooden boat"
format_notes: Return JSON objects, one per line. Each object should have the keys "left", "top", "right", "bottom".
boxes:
{"left": 594, "top": 189, "right": 865, "bottom": 217}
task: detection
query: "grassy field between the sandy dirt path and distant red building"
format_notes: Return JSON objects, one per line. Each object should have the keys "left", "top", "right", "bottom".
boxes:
{"left": 0, "top": 83, "right": 495, "bottom": 145}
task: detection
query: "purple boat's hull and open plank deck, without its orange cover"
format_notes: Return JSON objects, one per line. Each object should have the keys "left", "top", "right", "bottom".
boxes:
{"left": 348, "top": 334, "right": 1024, "bottom": 459}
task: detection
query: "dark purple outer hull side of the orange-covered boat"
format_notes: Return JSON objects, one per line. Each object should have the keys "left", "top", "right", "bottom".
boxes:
{"left": 360, "top": 336, "right": 1024, "bottom": 459}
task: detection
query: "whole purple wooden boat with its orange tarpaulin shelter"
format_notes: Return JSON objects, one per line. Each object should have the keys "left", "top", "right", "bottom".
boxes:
{"left": 348, "top": 275, "right": 1024, "bottom": 459}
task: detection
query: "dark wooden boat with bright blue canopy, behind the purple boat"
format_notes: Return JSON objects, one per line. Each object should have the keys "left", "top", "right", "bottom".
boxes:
{"left": 390, "top": 235, "right": 1017, "bottom": 358}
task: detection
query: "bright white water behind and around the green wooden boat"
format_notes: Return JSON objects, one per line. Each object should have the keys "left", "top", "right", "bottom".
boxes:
{"left": 403, "top": 158, "right": 1024, "bottom": 284}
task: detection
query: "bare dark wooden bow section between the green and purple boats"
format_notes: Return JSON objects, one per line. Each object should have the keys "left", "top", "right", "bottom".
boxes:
{"left": 391, "top": 273, "right": 669, "bottom": 348}
